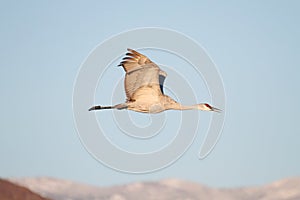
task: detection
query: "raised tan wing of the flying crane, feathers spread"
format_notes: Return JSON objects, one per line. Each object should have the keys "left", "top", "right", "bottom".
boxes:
{"left": 119, "top": 49, "right": 167, "bottom": 101}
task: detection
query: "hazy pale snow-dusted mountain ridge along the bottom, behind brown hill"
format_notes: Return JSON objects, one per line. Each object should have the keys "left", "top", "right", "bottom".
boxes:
{"left": 10, "top": 177, "right": 300, "bottom": 200}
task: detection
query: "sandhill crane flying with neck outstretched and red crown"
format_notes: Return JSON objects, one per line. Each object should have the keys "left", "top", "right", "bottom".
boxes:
{"left": 89, "top": 49, "right": 221, "bottom": 113}
